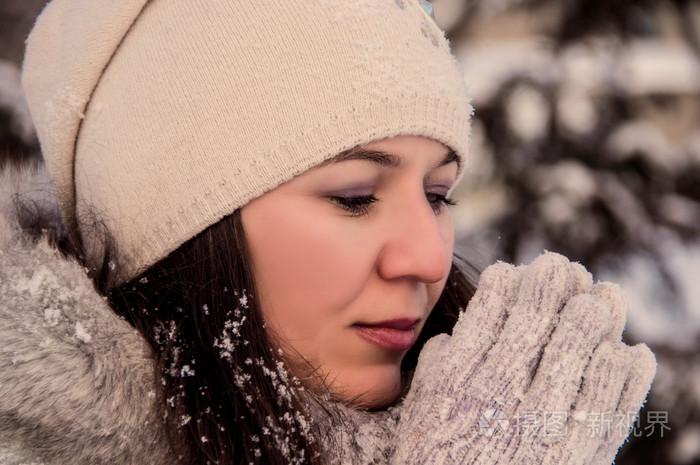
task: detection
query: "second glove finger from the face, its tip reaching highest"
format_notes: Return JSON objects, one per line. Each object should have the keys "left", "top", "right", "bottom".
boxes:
{"left": 477, "top": 253, "right": 587, "bottom": 406}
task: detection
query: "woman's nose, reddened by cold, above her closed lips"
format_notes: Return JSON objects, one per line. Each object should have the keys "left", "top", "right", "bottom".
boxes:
{"left": 378, "top": 196, "right": 454, "bottom": 283}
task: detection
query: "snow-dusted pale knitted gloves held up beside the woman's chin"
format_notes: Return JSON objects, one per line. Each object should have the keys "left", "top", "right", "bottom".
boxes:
{"left": 391, "top": 253, "right": 656, "bottom": 465}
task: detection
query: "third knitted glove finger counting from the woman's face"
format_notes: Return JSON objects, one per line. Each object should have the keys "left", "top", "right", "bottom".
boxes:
{"left": 519, "top": 294, "right": 610, "bottom": 412}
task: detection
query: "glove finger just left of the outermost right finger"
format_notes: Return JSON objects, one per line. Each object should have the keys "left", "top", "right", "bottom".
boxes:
{"left": 552, "top": 341, "right": 632, "bottom": 465}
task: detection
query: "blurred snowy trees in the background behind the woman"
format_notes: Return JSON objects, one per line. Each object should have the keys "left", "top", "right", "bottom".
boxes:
{"left": 0, "top": 0, "right": 700, "bottom": 465}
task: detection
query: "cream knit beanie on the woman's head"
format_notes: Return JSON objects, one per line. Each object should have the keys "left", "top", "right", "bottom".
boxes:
{"left": 22, "top": 0, "right": 471, "bottom": 281}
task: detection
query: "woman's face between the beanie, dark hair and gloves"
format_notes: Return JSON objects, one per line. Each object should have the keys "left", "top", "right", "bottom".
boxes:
{"left": 241, "top": 136, "right": 457, "bottom": 407}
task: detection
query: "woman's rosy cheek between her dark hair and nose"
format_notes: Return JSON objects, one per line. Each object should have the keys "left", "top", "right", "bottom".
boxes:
{"left": 243, "top": 204, "right": 372, "bottom": 332}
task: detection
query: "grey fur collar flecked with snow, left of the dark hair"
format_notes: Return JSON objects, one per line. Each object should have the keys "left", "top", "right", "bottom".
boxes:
{"left": 0, "top": 166, "right": 174, "bottom": 465}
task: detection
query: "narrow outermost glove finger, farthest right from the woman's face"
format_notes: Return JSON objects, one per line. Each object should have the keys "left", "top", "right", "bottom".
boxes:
{"left": 591, "top": 344, "right": 656, "bottom": 465}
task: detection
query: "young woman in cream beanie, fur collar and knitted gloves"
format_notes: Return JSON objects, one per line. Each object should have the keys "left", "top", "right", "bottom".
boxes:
{"left": 0, "top": 0, "right": 654, "bottom": 464}
